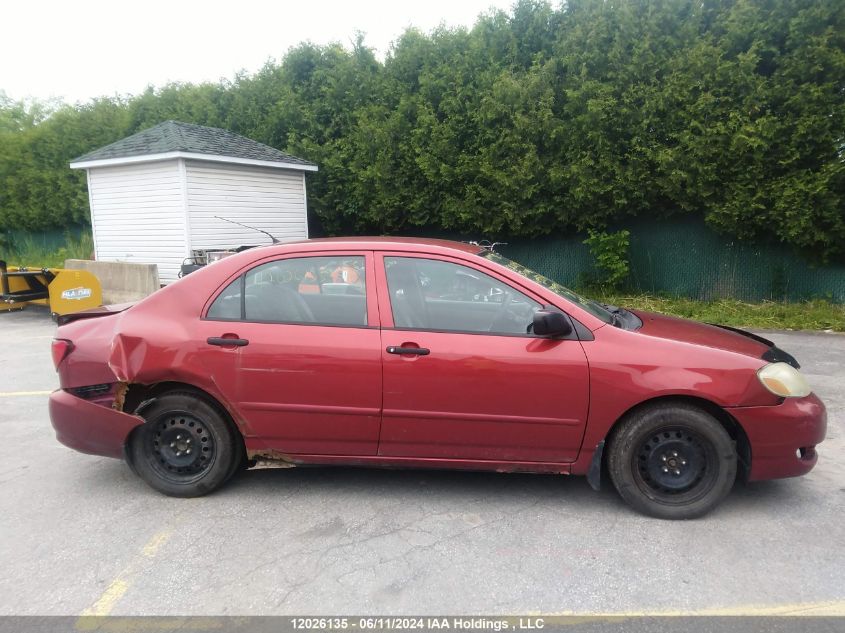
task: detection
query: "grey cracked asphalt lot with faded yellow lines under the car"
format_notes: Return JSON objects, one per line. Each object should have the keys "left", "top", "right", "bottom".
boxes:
{"left": 0, "top": 309, "right": 845, "bottom": 615}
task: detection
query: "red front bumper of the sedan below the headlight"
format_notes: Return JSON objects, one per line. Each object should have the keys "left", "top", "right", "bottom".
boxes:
{"left": 729, "top": 393, "right": 827, "bottom": 481}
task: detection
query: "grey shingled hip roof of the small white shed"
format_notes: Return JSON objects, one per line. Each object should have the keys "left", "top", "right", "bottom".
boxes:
{"left": 71, "top": 121, "right": 315, "bottom": 166}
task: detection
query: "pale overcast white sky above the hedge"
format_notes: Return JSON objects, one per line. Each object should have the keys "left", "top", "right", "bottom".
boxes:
{"left": 0, "top": 0, "right": 513, "bottom": 103}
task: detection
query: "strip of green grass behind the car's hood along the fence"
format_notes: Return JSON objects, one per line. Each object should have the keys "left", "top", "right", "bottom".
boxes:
{"left": 584, "top": 291, "right": 845, "bottom": 332}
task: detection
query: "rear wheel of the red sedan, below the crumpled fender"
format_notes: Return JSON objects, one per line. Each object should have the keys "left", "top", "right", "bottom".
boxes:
{"left": 128, "top": 392, "right": 244, "bottom": 497}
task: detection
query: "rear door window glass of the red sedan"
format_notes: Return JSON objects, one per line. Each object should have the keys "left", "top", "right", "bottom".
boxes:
{"left": 208, "top": 256, "right": 367, "bottom": 327}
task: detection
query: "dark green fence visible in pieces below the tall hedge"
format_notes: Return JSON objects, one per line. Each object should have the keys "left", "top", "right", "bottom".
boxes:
{"left": 8, "top": 218, "right": 845, "bottom": 303}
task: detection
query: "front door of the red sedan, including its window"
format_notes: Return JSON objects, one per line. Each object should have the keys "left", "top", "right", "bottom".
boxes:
{"left": 376, "top": 253, "right": 589, "bottom": 462}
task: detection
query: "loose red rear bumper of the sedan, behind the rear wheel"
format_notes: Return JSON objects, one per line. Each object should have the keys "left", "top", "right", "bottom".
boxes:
{"left": 49, "top": 389, "right": 144, "bottom": 458}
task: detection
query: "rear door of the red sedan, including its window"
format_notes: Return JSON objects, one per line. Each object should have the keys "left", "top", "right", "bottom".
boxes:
{"left": 196, "top": 252, "right": 381, "bottom": 455}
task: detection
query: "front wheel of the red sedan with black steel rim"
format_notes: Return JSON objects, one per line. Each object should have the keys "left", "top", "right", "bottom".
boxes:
{"left": 607, "top": 403, "right": 737, "bottom": 519}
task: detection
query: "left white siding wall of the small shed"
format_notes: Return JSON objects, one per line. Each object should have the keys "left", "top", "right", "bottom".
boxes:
{"left": 88, "top": 160, "right": 188, "bottom": 283}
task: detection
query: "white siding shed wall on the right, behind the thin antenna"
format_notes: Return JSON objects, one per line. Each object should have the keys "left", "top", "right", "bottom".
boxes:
{"left": 185, "top": 160, "right": 308, "bottom": 249}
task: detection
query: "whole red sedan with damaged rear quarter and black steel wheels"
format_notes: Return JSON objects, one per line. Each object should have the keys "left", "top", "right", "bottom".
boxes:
{"left": 44, "top": 238, "right": 826, "bottom": 519}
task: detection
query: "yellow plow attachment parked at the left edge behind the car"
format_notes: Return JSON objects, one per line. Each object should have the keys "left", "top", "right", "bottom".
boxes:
{"left": 0, "top": 260, "right": 103, "bottom": 314}
